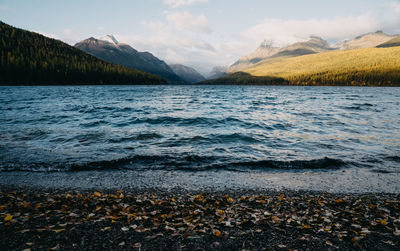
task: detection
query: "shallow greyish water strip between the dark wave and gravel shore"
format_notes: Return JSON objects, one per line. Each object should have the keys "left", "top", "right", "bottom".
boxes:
{"left": 0, "top": 168, "right": 400, "bottom": 194}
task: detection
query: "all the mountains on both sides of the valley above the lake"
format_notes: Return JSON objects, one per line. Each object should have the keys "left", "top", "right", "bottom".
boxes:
{"left": 0, "top": 22, "right": 400, "bottom": 86}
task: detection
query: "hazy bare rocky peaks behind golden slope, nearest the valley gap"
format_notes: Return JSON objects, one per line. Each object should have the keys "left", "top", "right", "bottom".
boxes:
{"left": 227, "top": 36, "right": 332, "bottom": 73}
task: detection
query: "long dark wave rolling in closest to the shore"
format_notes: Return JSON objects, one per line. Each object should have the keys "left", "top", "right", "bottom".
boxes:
{"left": 0, "top": 155, "right": 351, "bottom": 172}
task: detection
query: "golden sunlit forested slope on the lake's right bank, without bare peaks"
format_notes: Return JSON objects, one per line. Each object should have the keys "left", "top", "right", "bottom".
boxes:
{"left": 244, "top": 47, "right": 400, "bottom": 86}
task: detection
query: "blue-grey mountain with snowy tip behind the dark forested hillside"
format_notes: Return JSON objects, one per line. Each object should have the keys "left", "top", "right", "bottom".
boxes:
{"left": 75, "top": 35, "right": 184, "bottom": 83}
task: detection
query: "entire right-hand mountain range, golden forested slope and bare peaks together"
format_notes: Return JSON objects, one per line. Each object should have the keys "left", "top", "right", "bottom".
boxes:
{"left": 203, "top": 31, "right": 400, "bottom": 86}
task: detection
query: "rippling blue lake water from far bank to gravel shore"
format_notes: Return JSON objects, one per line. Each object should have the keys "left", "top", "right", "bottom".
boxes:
{"left": 0, "top": 86, "right": 400, "bottom": 192}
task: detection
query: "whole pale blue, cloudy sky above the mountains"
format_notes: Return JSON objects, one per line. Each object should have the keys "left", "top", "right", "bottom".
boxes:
{"left": 0, "top": 0, "right": 400, "bottom": 74}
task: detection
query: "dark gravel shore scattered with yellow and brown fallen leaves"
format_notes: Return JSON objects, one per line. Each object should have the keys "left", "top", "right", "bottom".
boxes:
{"left": 0, "top": 187, "right": 400, "bottom": 250}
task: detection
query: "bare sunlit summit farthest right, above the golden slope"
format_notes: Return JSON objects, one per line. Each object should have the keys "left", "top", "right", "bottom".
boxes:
{"left": 335, "top": 31, "right": 395, "bottom": 50}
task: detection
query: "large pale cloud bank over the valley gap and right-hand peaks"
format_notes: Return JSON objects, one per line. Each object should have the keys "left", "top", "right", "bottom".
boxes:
{"left": 89, "top": 1, "right": 400, "bottom": 74}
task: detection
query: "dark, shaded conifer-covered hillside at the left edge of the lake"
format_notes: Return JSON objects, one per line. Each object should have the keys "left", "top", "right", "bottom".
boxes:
{"left": 0, "top": 22, "right": 165, "bottom": 85}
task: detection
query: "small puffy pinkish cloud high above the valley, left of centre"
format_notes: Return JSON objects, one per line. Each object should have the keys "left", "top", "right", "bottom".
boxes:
{"left": 166, "top": 11, "right": 211, "bottom": 33}
